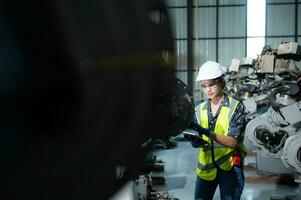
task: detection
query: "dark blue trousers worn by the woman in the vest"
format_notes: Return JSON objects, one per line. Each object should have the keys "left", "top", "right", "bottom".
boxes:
{"left": 195, "top": 168, "right": 238, "bottom": 200}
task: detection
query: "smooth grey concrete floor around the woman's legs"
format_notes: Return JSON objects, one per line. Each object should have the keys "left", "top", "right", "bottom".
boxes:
{"left": 153, "top": 136, "right": 301, "bottom": 200}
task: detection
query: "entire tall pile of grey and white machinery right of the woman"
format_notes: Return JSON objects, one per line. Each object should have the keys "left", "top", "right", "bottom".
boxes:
{"left": 226, "top": 42, "right": 301, "bottom": 182}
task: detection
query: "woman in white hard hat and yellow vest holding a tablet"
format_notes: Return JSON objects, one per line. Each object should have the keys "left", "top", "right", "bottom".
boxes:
{"left": 190, "top": 61, "right": 246, "bottom": 200}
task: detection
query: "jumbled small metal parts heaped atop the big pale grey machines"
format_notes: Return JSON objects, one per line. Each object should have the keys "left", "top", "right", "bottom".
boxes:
{"left": 225, "top": 43, "right": 301, "bottom": 106}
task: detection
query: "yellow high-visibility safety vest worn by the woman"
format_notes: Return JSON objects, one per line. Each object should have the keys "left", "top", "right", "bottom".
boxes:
{"left": 195, "top": 96, "right": 245, "bottom": 181}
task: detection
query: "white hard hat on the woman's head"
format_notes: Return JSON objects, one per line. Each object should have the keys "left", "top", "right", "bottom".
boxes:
{"left": 196, "top": 61, "right": 227, "bottom": 81}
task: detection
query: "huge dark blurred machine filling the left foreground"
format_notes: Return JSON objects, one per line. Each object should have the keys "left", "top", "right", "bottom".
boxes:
{"left": 0, "top": 0, "right": 193, "bottom": 199}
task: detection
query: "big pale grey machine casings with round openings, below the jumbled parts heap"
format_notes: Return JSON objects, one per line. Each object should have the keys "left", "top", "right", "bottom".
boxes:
{"left": 245, "top": 96, "right": 301, "bottom": 178}
